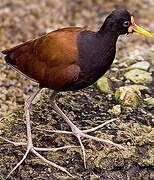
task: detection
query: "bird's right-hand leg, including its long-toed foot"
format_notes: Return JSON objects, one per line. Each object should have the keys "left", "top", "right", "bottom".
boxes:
{"left": 50, "top": 91, "right": 125, "bottom": 167}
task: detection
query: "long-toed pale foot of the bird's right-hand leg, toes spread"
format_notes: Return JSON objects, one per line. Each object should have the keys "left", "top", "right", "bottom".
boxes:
{"left": 38, "top": 119, "right": 126, "bottom": 168}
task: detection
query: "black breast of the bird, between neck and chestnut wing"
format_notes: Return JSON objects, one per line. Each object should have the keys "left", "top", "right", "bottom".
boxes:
{"left": 56, "top": 31, "right": 116, "bottom": 91}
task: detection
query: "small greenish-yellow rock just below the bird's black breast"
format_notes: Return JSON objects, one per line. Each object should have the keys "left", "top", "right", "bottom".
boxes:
{"left": 97, "top": 76, "right": 112, "bottom": 94}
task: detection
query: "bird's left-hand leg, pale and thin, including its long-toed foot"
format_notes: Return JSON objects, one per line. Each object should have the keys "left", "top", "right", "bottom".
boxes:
{"left": 1, "top": 88, "right": 72, "bottom": 178}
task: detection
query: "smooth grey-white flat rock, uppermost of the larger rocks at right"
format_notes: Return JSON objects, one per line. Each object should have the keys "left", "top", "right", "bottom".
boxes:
{"left": 127, "top": 61, "right": 150, "bottom": 71}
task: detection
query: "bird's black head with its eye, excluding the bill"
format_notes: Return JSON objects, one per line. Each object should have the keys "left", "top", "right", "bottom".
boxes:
{"left": 99, "top": 9, "right": 131, "bottom": 35}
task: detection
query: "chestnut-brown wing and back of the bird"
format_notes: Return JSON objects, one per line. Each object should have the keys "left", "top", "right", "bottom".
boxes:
{"left": 2, "top": 28, "right": 85, "bottom": 89}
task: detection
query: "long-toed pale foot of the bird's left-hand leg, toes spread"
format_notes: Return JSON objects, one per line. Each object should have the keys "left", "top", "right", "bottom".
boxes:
{"left": 0, "top": 136, "right": 73, "bottom": 179}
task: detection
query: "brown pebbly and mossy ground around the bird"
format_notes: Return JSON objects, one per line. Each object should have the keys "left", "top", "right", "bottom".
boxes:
{"left": 0, "top": 0, "right": 154, "bottom": 180}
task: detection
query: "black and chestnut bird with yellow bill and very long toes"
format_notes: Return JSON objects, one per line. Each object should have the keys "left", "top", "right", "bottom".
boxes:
{"left": 1, "top": 9, "right": 152, "bottom": 176}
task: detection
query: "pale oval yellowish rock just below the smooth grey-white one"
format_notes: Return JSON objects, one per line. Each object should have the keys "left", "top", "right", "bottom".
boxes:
{"left": 124, "top": 69, "right": 152, "bottom": 83}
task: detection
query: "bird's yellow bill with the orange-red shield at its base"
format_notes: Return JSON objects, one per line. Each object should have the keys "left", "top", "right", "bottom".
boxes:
{"left": 128, "top": 16, "right": 152, "bottom": 37}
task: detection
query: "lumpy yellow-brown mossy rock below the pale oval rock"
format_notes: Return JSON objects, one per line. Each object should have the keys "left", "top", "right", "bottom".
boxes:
{"left": 115, "top": 85, "right": 149, "bottom": 106}
